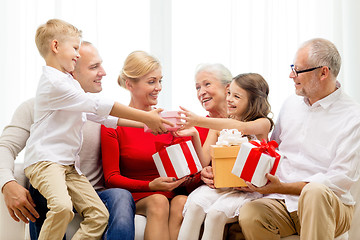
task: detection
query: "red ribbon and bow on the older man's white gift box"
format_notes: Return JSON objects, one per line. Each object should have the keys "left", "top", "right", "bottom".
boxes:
{"left": 240, "top": 139, "right": 280, "bottom": 182}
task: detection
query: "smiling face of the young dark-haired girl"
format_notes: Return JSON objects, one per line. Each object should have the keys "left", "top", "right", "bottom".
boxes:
{"left": 226, "top": 81, "right": 249, "bottom": 119}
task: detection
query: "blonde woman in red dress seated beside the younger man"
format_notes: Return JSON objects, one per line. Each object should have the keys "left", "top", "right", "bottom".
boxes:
{"left": 101, "top": 51, "right": 186, "bottom": 240}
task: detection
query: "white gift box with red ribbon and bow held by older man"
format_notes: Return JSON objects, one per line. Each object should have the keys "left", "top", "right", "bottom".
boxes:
{"left": 231, "top": 141, "right": 281, "bottom": 187}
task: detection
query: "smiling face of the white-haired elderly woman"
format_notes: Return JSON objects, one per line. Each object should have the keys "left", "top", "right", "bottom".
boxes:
{"left": 195, "top": 72, "right": 226, "bottom": 112}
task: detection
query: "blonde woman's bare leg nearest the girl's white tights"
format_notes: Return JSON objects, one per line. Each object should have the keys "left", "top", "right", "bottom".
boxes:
{"left": 169, "top": 195, "right": 187, "bottom": 240}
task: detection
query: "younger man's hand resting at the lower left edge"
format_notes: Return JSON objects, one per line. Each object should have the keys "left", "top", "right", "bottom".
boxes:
{"left": 3, "top": 181, "right": 39, "bottom": 223}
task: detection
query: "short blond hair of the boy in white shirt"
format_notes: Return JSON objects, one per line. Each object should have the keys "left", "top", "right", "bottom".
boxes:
{"left": 35, "top": 19, "right": 82, "bottom": 58}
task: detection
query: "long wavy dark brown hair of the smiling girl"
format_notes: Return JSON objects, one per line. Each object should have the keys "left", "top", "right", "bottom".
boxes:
{"left": 233, "top": 73, "right": 274, "bottom": 130}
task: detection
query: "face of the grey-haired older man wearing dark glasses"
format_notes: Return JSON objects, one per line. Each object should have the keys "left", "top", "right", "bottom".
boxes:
{"left": 289, "top": 48, "right": 319, "bottom": 102}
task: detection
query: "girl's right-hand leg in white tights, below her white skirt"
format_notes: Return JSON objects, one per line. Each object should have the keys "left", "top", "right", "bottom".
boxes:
{"left": 201, "top": 210, "right": 237, "bottom": 240}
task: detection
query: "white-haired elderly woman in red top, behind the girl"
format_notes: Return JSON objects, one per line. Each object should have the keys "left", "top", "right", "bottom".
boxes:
{"left": 195, "top": 63, "right": 232, "bottom": 144}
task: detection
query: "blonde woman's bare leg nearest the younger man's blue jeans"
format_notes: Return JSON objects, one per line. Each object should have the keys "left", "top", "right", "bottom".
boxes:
{"left": 136, "top": 194, "right": 170, "bottom": 240}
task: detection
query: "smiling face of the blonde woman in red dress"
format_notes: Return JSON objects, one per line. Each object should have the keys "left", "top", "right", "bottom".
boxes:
{"left": 129, "top": 68, "right": 162, "bottom": 109}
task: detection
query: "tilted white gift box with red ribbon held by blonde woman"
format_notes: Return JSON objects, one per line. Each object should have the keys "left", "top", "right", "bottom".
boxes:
{"left": 152, "top": 140, "right": 202, "bottom": 179}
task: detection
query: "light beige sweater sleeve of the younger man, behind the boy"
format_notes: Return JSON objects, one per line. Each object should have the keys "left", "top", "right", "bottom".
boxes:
{"left": 0, "top": 99, "right": 34, "bottom": 189}
